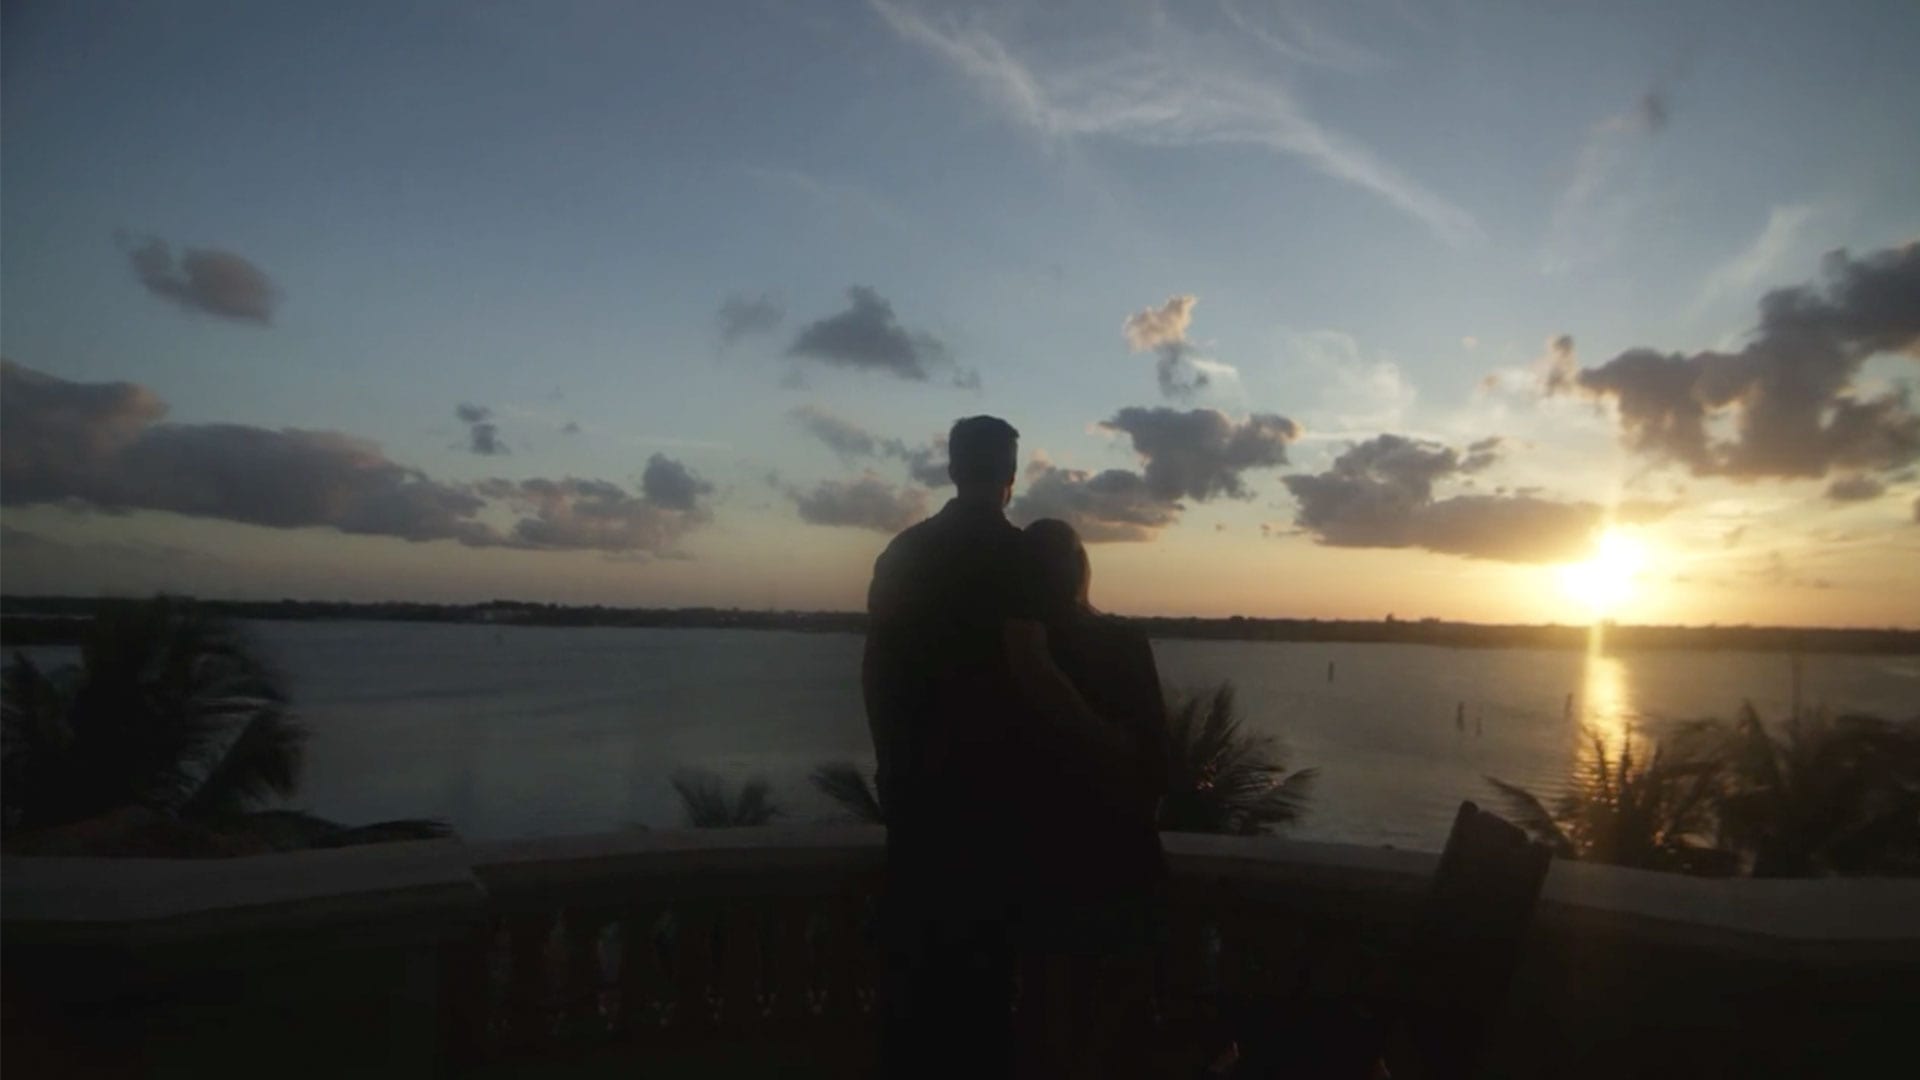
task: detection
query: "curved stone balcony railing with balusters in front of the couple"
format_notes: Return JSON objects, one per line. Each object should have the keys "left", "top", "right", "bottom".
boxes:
{"left": 0, "top": 826, "right": 1920, "bottom": 1076}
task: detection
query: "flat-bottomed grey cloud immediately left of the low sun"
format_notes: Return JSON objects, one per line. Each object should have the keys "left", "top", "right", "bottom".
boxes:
{"left": 1283, "top": 434, "right": 1612, "bottom": 563}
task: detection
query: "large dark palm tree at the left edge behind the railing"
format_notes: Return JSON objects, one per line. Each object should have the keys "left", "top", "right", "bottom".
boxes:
{"left": 0, "top": 596, "right": 447, "bottom": 855}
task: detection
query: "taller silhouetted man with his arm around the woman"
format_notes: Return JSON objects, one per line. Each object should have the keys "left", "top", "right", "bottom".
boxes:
{"left": 862, "top": 417, "right": 1127, "bottom": 1078}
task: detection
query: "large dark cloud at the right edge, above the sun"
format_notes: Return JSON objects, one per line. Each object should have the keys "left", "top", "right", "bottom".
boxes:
{"left": 1548, "top": 244, "right": 1920, "bottom": 480}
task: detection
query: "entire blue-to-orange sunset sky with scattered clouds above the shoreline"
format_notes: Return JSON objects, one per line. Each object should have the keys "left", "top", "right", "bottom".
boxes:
{"left": 0, "top": 0, "right": 1920, "bottom": 626}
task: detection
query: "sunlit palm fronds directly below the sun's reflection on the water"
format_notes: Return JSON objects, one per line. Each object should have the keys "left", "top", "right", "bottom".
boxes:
{"left": 1486, "top": 730, "right": 1734, "bottom": 874}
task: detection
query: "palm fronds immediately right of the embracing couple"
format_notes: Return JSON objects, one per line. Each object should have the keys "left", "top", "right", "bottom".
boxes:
{"left": 1160, "top": 680, "right": 1319, "bottom": 836}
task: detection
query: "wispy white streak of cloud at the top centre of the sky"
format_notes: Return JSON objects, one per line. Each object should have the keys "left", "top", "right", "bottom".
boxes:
{"left": 868, "top": 0, "right": 1482, "bottom": 244}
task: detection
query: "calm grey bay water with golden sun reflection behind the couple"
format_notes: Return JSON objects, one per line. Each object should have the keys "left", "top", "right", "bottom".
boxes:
{"left": 18, "top": 623, "right": 1920, "bottom": 849}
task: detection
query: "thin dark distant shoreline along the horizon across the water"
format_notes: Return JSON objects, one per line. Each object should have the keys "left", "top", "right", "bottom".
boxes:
{"left": 0, "top": 596, "right": 1920, "bottom": 655}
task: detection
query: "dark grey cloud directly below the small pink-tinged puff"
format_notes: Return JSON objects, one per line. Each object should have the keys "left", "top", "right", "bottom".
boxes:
{"left": 1100, "top": 407, "right": 1300, "bottom": 502}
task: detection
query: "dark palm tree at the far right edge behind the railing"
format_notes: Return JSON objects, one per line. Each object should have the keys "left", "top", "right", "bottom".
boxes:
{"left": 1716, "top": 703, "right": 1920, "bottom": 878}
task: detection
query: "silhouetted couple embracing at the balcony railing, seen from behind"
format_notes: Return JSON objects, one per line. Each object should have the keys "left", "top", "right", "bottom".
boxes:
{"left": 862, "top": 417, "right": 1167, "bottom": 1078}
